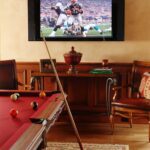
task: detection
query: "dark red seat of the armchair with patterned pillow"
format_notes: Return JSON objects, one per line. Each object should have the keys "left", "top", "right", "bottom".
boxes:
{"left": 112, "top": 98, "right": 150, "bottom": 111}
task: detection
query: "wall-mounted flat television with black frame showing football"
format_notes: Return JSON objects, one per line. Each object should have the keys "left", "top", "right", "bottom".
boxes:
{"left": 28, "top": 0, "right": 125, "bottom": 41}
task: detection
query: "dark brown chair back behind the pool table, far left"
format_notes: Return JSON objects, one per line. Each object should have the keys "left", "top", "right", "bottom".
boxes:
{"left": 0, "top": 59, "right": 18, "bottom": 90}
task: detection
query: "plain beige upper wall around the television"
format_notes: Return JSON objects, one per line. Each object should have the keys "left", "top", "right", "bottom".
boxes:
{"left": 0, "top": 0, "right": 150, "bottom": 62}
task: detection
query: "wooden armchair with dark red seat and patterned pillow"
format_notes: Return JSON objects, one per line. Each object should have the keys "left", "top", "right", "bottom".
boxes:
{"left": 110, "top": 61, "right": 150, "bottom": 142}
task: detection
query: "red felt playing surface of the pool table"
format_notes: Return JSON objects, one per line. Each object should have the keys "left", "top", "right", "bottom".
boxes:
{"left": 0, "top": 91, "right": 61, "bottom": 149}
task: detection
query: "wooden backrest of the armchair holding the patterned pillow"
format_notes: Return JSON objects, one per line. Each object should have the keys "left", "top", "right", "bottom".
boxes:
{"left": 131, "top": 60, "right": 150, "bottom": 94}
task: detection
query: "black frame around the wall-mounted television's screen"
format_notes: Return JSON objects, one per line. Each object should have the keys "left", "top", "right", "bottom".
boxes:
{"left": 28, "top": 0, "right": 125, "bottom": 41}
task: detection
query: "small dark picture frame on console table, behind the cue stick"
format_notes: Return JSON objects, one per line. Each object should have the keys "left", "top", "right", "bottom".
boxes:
{"left": 40, "top": 59, "right": 56, "bottom": 73}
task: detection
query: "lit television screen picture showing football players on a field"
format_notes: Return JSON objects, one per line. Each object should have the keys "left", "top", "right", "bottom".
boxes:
{"left": 40, "top": 0, "right": 112, "bottom": 38}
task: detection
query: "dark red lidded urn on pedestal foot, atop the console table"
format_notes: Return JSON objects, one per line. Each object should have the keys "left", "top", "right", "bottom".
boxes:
{"left": 64, "top": 46, "right": 82, "bottom": 74}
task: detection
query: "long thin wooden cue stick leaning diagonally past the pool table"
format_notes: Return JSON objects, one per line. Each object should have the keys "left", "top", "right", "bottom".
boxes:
{"left": 43, "top": 37, "right": 83, "bottom": 150}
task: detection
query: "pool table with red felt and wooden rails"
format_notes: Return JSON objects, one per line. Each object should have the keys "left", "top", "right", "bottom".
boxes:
{"left": 0, "top": 90, "right": 64, "bottom": 150}
